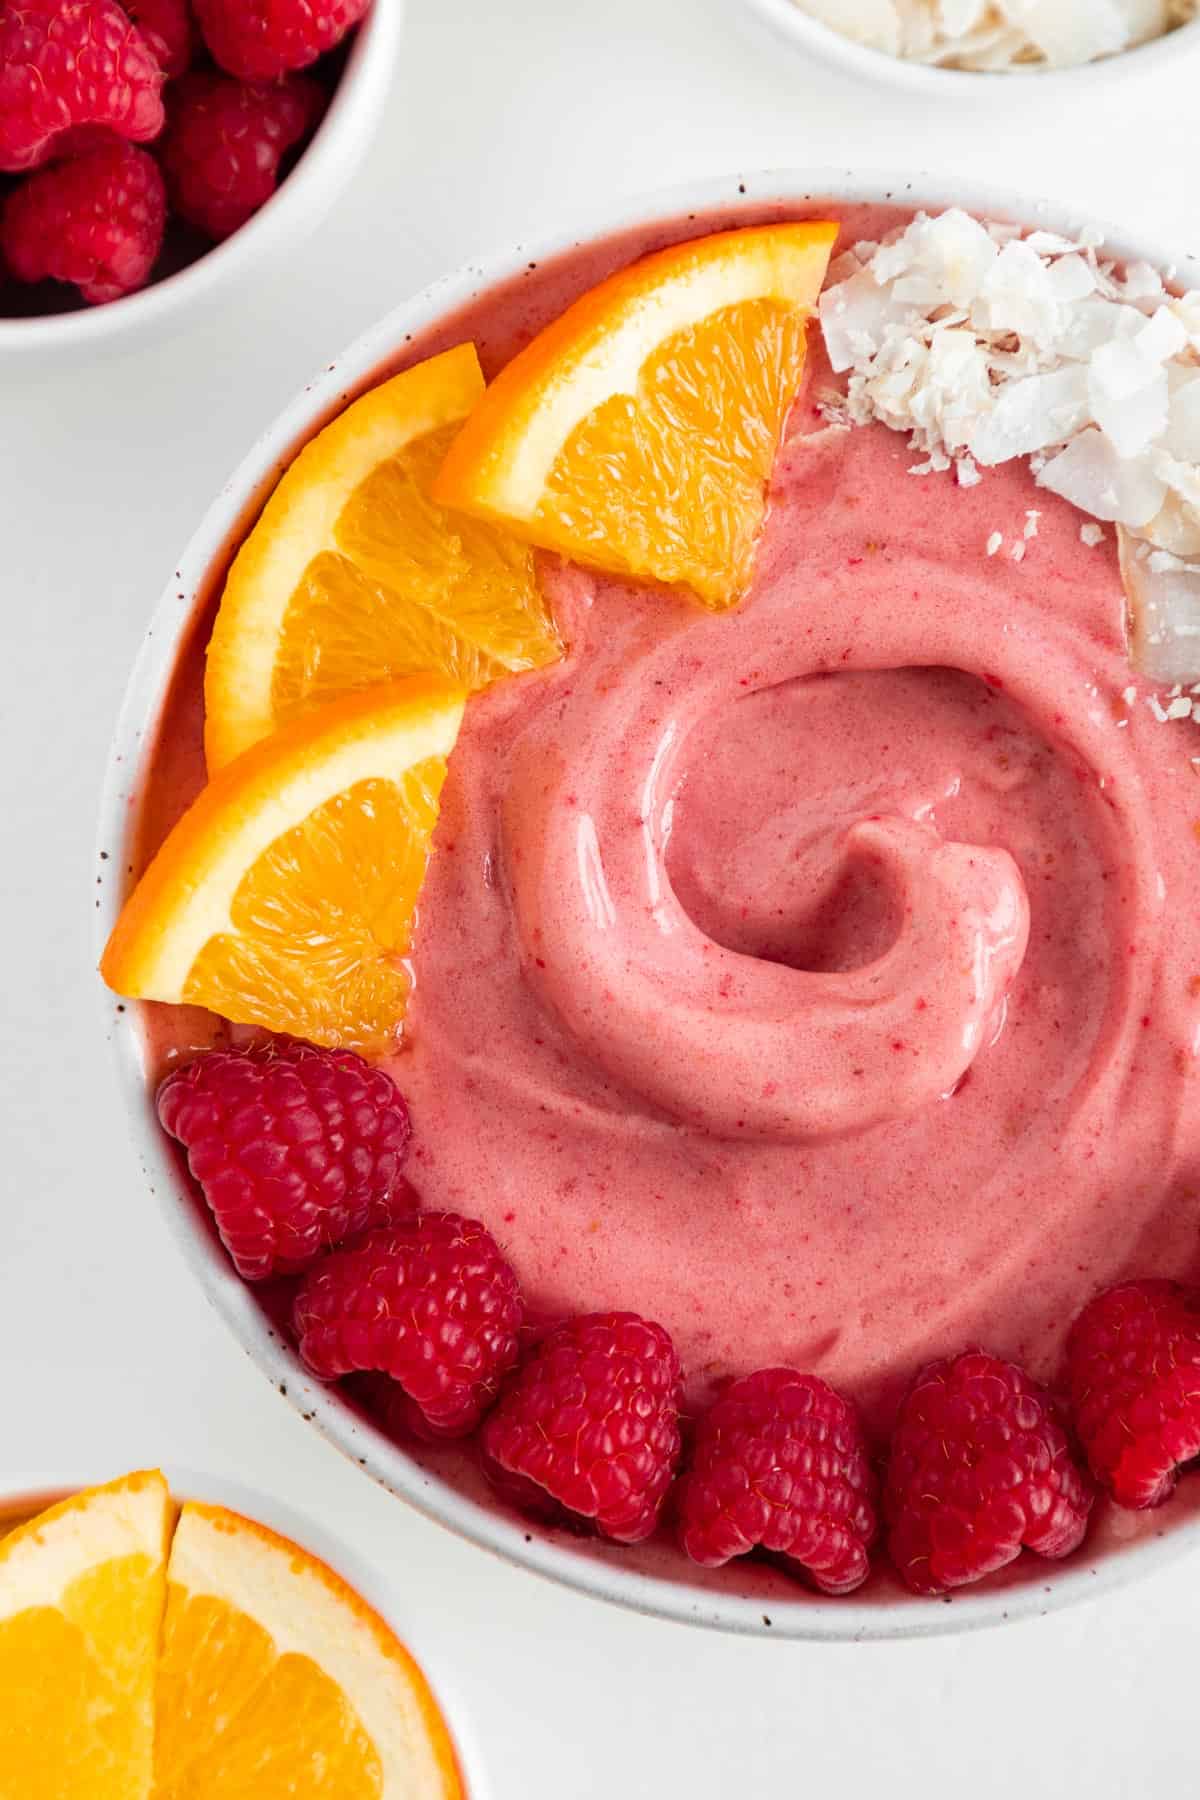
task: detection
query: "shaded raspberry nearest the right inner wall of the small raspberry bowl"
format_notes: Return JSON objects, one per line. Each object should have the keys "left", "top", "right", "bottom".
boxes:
{"left": 164, "top": 72, "right": 324, "bottom": 238}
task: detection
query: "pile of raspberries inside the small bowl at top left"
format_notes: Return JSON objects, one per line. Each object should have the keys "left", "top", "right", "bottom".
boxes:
{"left": 0, "top": 0, "right": 369, "bottom": 304}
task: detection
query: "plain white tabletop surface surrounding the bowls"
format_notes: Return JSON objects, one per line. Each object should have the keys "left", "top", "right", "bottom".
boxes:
{"left": 0, "top": 0, "right": 1200, "bottom": 1800}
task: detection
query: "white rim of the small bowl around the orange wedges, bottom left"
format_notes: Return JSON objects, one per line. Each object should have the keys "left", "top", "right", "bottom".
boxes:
{"left": 0, "top": 1465, "right": 491, "bottom": 1800}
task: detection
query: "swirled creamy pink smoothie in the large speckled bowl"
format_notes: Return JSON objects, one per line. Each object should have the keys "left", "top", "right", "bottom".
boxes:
{"left": 148, "top": 200, "right": 1200, "bottom": 1432}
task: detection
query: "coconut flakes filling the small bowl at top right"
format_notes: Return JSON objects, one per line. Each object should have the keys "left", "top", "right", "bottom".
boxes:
{"left": 795, "top": 0, "right": 1198, "bottom": 71}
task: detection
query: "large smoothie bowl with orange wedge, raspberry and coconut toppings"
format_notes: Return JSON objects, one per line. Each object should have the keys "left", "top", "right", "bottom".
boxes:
{"left": 99, "top": 178, "right": 1200, "bottom": 1636}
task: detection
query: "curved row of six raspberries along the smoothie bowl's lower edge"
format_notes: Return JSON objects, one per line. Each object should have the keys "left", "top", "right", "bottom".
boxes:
{"left": 158, "top": 1040, "right": 1200, "bottom": 1595}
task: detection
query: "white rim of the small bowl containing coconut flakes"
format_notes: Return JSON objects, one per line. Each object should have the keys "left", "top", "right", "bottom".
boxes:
{"left": 730, "top": 0, "right": 1200, "bottom": 97}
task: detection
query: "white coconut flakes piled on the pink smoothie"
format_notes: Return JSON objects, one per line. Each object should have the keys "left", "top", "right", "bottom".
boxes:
{"left": 820, "top": 209, "right": 1200, "bottom": 680}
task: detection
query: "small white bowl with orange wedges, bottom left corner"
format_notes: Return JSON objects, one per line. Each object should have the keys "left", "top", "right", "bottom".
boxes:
{"left": 0, "top": 1469, "right": 484, "bottom": 1800}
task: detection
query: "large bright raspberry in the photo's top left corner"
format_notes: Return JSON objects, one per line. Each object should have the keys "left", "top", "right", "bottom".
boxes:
{"left": 0, "top": 0, "right": 162, "bottom": 173}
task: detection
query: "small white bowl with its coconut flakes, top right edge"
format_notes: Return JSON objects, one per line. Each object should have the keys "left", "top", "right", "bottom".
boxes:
{"left": 738, "top": 0, "right": 1200, "bottom": 99}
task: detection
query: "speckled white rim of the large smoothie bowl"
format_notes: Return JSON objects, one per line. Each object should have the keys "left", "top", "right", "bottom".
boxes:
{"left": 98, "top": 169, "right": 1200, "bottom": 1640}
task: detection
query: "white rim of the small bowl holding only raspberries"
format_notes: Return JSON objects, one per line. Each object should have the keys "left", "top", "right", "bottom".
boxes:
{"left": 0, "top": 0, "right": 403, "bottom": 356}
